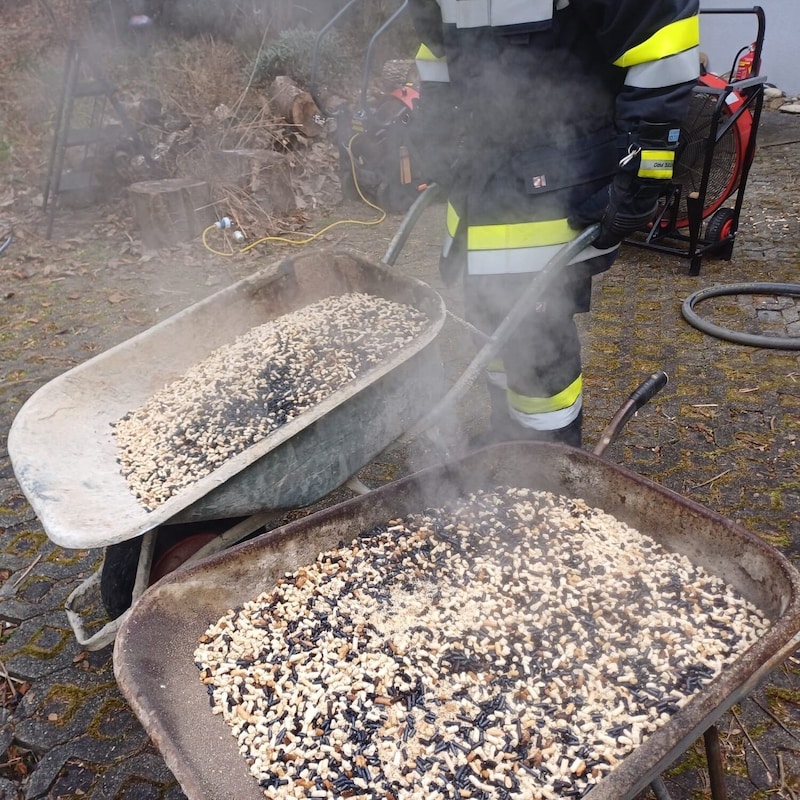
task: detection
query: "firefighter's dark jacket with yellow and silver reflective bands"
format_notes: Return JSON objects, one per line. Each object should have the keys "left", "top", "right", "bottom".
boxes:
{"left": 410, "top": 0, "right": 699, "bottom": 275}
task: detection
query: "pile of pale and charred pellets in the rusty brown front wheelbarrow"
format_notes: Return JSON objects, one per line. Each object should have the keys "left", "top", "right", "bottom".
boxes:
{"left": 194, "top": 487, "right": 769, "bottom": 800}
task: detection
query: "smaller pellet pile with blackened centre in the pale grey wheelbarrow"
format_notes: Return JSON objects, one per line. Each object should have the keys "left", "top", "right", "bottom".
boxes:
{"left": 112, "top": 292, "right": 430, "bottom": 510}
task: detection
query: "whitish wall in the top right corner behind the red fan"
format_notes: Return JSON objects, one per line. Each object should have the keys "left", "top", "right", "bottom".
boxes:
{"left": 700, "top": 0, "right": 800, "bottom": 96}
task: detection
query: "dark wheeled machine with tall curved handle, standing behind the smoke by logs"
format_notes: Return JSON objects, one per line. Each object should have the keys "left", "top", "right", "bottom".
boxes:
{"left": 309, "top": 0, "right": 424, "bottom": 213}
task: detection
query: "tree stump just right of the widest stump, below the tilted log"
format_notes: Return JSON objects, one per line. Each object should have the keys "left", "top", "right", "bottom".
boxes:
{"left": 214, "top": 149, "right": 297, "bottom": 216}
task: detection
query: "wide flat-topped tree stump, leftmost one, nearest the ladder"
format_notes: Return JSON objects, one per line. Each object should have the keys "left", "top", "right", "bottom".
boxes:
{"left": 128, "top": 178, "right": 216, "bottom": 250}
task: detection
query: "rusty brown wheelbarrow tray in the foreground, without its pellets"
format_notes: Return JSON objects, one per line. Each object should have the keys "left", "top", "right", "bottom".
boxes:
{"left": 114, "top": 443, "right": 800, "bottom": 800}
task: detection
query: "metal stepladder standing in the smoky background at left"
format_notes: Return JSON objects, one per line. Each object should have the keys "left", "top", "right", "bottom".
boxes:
{"left": 42, "top": 41, "right": 152, "bottom": 239}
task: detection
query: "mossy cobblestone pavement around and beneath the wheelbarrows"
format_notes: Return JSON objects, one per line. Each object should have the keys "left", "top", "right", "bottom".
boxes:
{"left": 0, "top": 108, "right": 800, "bottom": 800}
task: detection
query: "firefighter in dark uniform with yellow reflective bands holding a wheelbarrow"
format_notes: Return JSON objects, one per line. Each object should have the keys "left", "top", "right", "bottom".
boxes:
{"left": 410, "top": 0, "right": 699, "bottom": 446}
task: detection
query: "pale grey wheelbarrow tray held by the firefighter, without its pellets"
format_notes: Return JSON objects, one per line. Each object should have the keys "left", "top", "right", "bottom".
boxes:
{"left": 8, "top": 250, "right": 445, "bottom": 548}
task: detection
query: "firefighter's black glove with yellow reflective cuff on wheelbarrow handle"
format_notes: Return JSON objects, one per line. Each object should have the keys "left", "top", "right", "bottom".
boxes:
{"left": 594, "top": 122, "right": 680, "bottom": 249}
